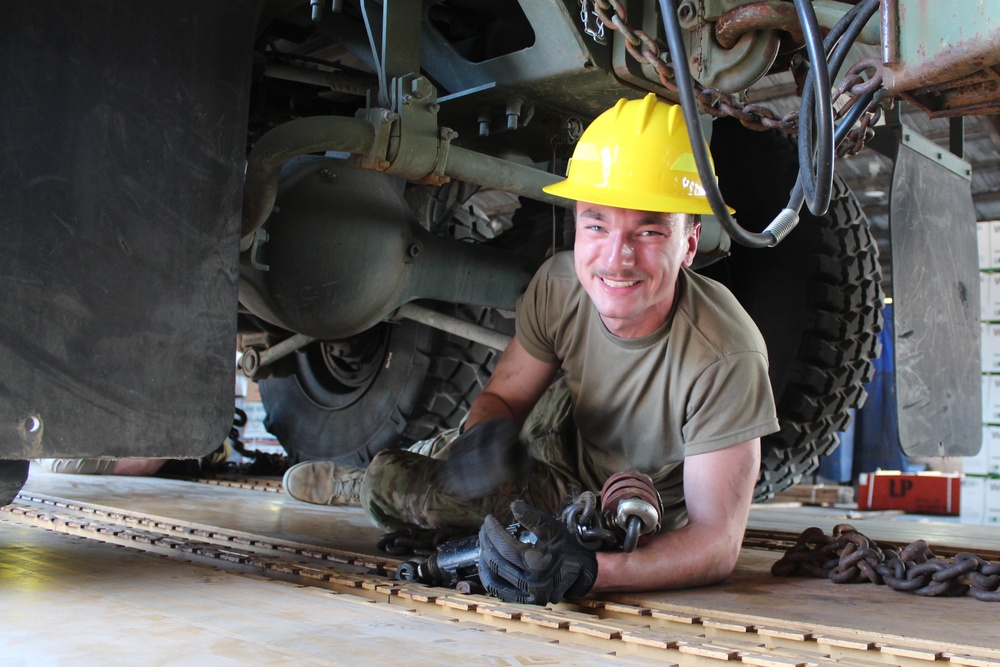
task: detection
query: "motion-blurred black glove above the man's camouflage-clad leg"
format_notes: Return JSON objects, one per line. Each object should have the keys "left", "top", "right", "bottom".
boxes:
{"left": 435, "top": 419, "right": 531, "bottom": 500}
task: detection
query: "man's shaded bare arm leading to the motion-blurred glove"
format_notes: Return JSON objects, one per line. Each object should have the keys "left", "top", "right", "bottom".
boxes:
{"left": 465, "top": 336, "right": 559, "bottom": 428}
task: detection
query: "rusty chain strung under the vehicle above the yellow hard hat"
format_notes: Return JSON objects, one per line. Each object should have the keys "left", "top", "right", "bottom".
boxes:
{"left": 582, "top": 0, "right": 884, "bottom": 155}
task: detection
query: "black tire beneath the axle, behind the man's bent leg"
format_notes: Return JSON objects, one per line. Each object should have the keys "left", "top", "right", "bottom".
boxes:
{"left": 254, "top": 321, "right": 497, "bottom": 467}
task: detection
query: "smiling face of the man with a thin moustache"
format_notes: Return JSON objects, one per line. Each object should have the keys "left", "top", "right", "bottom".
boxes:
{"left": 573, "top": 202, "right": 701, "bottom": 338}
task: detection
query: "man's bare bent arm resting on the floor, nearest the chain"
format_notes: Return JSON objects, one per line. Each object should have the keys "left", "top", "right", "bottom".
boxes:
{"left": 593, "top": 438, "right": 760, "bottom": 591}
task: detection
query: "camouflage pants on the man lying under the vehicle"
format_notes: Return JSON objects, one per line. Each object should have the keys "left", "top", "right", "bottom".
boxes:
{"left": 361, "top": 382, "right": 582, "bottom": 530}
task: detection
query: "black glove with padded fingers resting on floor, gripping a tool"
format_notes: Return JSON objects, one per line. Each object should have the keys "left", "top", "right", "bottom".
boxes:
{"left": 479, "top": 500, "right": 597, "bottom": 605}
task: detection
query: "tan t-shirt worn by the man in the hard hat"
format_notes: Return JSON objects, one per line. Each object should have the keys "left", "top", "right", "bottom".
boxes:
{"left": 516, "top": 252, "right": 779, "bottom": 520}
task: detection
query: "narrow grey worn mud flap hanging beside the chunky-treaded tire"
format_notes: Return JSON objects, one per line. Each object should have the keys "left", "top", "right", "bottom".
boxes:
{"left": 889, "top": 127, "right": 982, "bottom": 456}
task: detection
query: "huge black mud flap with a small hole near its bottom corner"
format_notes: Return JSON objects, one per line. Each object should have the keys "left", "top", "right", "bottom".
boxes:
{"left": 0, "top": 0, "right": 258, "bottom": 459}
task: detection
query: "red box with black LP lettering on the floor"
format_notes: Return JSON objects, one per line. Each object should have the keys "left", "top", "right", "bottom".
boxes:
{"left": 858, "top": 470, "right": 962, "bottom": 515}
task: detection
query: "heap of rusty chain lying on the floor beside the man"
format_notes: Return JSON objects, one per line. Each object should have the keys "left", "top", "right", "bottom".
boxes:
{"left": 771, "top": 524, "right": 1000, "bottom": 602}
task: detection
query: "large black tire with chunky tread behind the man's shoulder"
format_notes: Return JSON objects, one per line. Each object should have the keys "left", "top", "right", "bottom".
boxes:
{"left": 703, "top": 119, "right": 883, "bottom": 501}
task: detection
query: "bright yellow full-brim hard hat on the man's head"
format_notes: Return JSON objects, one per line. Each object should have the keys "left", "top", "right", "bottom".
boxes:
{"left": 542, "top": 93, "right": 733, "bottom": 215}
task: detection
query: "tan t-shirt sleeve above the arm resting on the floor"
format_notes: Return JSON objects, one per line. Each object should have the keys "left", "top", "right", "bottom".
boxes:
{"left": 682, "top": 351, "right": 780, "bottom": 456}
